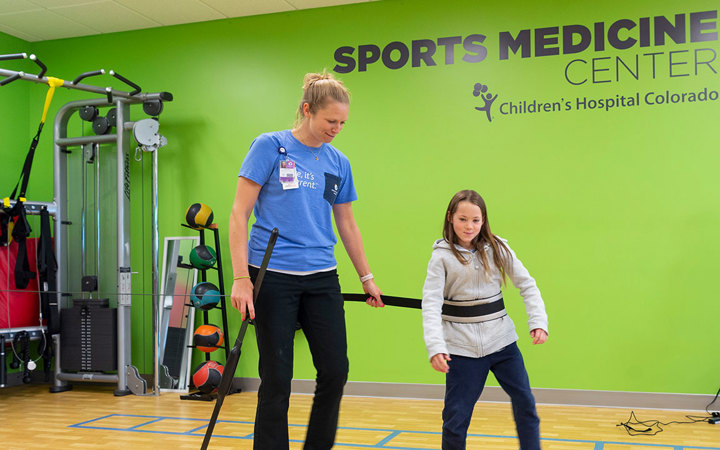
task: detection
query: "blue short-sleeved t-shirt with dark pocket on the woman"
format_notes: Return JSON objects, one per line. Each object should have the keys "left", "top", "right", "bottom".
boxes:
{"left": 238, "top": 130, "right": 357, "bottom": 272}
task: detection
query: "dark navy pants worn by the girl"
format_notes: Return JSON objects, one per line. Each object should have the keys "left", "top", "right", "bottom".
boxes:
{"left": 442, "top": 342, "right": 540, "bottom": 450}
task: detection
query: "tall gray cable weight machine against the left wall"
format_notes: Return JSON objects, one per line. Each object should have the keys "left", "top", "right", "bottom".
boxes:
{"left": 0, "top": 53, "right": 173, "bottom": 395}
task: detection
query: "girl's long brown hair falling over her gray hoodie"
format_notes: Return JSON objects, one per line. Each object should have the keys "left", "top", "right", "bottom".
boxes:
{"left": 443, "top": 189, "right": 512, "bottom": 283}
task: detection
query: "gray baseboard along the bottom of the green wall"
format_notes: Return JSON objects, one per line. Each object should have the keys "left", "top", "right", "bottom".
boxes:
{"left": 235, "top": 378, "right": 714, "bottom": 411}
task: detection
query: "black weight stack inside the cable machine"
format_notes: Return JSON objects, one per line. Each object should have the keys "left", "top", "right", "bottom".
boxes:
{"left": 60, "top": 299, "right": 117, "bottom": 372}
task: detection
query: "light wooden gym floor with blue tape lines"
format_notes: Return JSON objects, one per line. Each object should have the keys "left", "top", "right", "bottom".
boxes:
{"left": 0, "top": 384, "right": 720, "bottom": 450}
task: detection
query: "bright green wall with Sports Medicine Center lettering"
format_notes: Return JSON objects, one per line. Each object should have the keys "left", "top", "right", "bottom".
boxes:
{"left": 0, "top": 0, "right": 720, "bottom": 394}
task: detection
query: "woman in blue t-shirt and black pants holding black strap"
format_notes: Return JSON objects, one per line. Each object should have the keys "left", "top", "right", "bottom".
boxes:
{"left": 229, "top": 73, "right": 384, "bottom": 450}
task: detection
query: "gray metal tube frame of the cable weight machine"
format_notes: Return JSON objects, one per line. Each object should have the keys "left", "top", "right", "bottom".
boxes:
{"left": 0, "top": 59, "right": 172, "bottom": 395}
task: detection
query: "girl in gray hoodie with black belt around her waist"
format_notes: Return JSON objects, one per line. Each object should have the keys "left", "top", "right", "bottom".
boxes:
{"left": 422, "top": 190, "right": 548, "bottom": 450}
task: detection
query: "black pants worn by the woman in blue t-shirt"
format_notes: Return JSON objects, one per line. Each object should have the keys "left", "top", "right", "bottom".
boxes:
{"left": 250, "top": 267, "right": 348, "bottom": 450}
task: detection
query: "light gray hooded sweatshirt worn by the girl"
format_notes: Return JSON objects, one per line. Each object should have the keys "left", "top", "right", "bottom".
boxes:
{"left": 422, "top": 239, "right": 548, "bottom": 358}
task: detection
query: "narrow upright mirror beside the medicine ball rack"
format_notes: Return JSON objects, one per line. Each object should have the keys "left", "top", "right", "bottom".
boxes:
{"left": 157, "top": 237, "right": 200, "bottom": 392}
